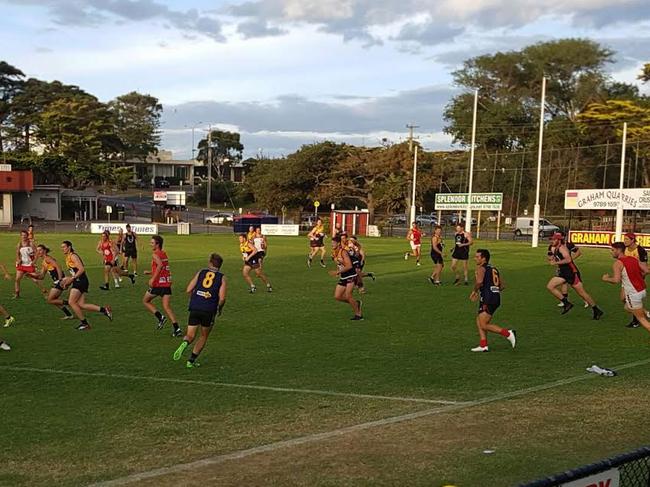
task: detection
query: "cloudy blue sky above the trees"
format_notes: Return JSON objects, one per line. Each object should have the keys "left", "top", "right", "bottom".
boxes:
{"left": 0, "top": 0, "right": 650, "bottom": 159}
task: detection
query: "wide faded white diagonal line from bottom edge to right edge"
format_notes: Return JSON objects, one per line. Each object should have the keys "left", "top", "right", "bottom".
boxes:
{"left": 89, "top": 359, "right": 650, "bottom": 487}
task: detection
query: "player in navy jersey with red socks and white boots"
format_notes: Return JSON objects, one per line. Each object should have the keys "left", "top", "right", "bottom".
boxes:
{"left": 469, "top": 249, "right": 517, "bottom": 352}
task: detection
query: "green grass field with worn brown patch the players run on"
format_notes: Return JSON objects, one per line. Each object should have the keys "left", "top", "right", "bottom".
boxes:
{"left": 0, "top": 235, "right": 650, "bottom": 486}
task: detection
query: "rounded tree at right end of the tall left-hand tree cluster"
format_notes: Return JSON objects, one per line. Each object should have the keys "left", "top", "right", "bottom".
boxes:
{"left": 108, "top": 91, "right": 162, "bottom": 161}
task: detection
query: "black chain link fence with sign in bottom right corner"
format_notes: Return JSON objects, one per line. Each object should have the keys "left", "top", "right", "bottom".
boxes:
{"left": 519, "top": 446, "right": 650, "bottom": 487}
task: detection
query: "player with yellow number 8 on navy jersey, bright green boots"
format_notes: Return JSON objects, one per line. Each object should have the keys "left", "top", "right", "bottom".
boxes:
{"left": 174, "top": 254, "right": 226, "bottom": 369}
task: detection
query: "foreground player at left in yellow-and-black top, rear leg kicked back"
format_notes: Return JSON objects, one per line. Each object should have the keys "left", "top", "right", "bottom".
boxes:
{"left": 59, "top": 240, "right": 113, "bottom": 331}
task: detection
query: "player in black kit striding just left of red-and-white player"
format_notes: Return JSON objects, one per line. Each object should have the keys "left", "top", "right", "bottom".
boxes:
{"left": 546, "top": 232, "right": 604, "bottom": 320}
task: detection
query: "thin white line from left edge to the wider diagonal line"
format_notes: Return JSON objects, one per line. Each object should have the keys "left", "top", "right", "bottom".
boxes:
{"left": 0, "top": 365, "right": 464, "bottom": 405}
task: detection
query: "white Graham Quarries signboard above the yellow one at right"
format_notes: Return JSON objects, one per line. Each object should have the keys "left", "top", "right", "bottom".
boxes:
{"left": 564, "top": 188, "right": 650, "bottom": 210}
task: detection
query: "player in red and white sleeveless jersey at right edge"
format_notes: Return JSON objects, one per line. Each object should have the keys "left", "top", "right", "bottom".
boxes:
{"left": 603, "top": 242, "right": 650, "bottom": 331}
